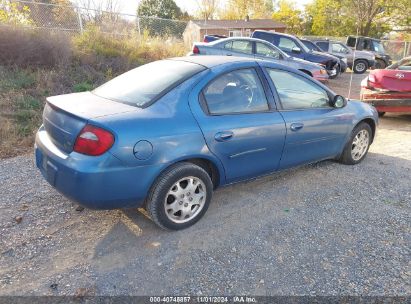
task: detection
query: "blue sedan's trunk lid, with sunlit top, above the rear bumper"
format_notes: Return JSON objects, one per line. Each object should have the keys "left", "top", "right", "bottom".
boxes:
{"left": 43, "top": 92, "right": 138, "bottom": 153}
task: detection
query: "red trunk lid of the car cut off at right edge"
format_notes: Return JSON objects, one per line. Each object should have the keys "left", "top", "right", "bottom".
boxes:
{"left": 373, "top": 69, "right": 411, "bottom": 92}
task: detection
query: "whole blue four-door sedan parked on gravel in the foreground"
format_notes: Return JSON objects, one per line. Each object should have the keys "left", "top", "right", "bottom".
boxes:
{"left": 35, "top": 56, "right": 378, "bottom": 230}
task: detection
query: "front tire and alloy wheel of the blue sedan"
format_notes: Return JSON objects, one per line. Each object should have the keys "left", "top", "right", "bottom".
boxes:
{"left": 340, "top": 122, "right": 373, "bottom": 165}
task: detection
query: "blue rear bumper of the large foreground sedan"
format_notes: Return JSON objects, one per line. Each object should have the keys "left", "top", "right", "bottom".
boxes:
{"left": 35, "top": 127, "right": 161, "bottom": 209}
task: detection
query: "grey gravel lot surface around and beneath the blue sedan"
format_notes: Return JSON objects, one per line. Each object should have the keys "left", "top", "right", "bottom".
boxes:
{"left": 0, "top": 74, "right": 411, "bottom": 295}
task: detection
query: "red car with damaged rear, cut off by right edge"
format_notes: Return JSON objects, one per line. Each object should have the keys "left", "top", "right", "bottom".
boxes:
{"left": 361, "top": 57, "right": 411, "bottom": 116}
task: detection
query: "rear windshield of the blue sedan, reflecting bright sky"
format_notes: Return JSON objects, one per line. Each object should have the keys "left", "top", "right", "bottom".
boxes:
{"left": 93, "top": 60, "right": 205, "bottom": 107}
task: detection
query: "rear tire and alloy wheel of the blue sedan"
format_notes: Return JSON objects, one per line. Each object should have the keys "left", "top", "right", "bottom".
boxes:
{"left": 146, "top": 162, "right": 213, "bottom": 230}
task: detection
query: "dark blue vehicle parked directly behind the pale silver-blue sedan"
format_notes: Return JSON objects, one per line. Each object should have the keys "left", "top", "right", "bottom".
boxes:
{"left": 251, "top": 30, "right": 341, "bottom": 78}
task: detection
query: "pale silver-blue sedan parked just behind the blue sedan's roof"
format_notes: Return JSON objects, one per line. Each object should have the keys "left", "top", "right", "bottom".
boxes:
{"left": 190, "top": 37, "right": 329, "bottom": 81}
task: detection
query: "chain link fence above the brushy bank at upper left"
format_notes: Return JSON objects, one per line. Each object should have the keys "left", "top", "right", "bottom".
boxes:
{"left": 0, "top": 0, "right": 187, "bottom": 38}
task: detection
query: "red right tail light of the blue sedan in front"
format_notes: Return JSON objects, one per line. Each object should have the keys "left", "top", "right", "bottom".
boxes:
{"left": 74, "top": 125, "right": 114, "bottom": 156}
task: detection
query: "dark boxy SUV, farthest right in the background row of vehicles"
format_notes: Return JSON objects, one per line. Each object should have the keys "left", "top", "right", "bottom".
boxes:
{"left": 346, "top": 36, "right": 392, "bottom": 69}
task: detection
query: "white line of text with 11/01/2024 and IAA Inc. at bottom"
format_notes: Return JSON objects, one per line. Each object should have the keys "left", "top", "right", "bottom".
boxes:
{"left": 150, "top": 296, "right": 257, "bottom": 303}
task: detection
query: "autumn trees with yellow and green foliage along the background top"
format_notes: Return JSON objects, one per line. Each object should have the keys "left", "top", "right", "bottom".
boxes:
{"left": 0, "top": 0, "right": 411, "bottom": 38}
